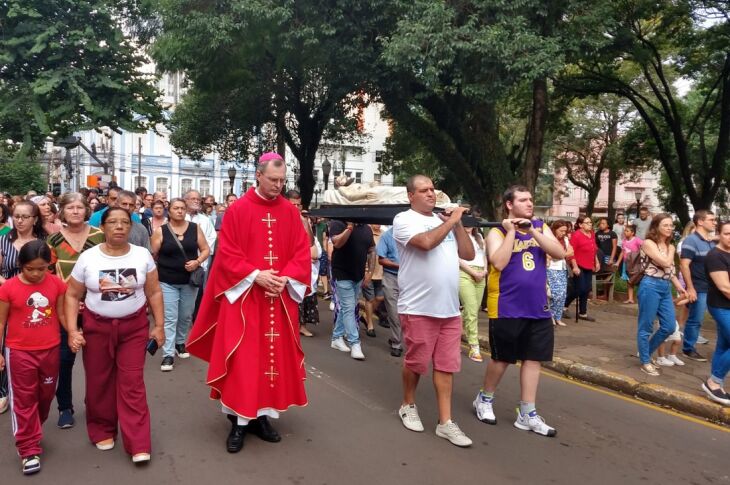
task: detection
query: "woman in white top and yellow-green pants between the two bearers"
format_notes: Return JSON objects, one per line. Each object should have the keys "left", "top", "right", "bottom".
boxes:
{"left": 459, "top": 227, "right": 487, "bottom": 362}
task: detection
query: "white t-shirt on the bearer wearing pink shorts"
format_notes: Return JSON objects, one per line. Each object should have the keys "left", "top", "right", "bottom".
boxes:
{"left": 393, "top": 209, "right": 460, "bottom": 318}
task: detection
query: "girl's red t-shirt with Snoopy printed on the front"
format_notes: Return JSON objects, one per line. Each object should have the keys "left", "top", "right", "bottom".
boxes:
{"left": 0, "top": 273, "right": 66, "bottom": 350}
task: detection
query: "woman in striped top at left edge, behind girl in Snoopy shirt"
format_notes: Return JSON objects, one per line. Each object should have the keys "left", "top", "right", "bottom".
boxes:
{"left": 0, "top": 200, "right": 46, "bottom": 413}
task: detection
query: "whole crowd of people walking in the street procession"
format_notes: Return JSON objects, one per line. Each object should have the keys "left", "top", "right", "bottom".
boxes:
{"left": 0, "top": 158, "right": 730, "bottom": 474}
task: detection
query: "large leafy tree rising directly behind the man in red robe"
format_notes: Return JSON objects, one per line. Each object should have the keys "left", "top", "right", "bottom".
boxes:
{"left": 153, "top": 0, "right": 390, "bottom": 205}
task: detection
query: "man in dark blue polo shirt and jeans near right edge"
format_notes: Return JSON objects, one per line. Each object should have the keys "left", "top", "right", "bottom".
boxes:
{"left": 679, "top": 210, "right": 717, "bottom": 362}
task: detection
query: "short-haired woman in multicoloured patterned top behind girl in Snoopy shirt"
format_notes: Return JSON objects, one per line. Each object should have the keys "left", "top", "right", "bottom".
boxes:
{"left": 46, "top": 192, "right": 104, "bottom": 429}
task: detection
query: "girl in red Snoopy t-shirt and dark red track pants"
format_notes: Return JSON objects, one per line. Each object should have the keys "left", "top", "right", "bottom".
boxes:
{"left": 0, "top": 240, "right": 82, "bottom": 475}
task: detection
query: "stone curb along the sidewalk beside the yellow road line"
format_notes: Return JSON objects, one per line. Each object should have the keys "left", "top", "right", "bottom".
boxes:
{"left": 472, "top": 337, "right": 730, "bottom": 426}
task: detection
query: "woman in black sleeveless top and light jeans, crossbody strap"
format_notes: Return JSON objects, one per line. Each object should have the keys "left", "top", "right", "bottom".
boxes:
{"left": 151, "top": 198, "right": 210, "bottom": 372}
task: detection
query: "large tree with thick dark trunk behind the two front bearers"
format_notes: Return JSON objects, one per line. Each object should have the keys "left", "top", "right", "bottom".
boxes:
{"left": 380, "top": 0, "right": 602, "bottom": 217}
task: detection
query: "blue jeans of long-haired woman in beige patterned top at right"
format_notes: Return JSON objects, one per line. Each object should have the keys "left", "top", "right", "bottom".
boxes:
{"left": 636, "top": 276, "right": 677, "bottom": 364}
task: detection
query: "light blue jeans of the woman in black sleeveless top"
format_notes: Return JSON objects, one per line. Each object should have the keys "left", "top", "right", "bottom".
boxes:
{"left": 160, "top": 281, "right": 198, "bottom": 357}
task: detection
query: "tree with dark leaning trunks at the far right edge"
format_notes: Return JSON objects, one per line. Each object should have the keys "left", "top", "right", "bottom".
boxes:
{"left": 561, "top": 0, "right": 730, "bottom": 223}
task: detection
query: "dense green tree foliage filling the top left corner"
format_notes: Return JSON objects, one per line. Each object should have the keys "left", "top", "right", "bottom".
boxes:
{"left": 0, "top": 0, "right": 162, "bottom": 160}
